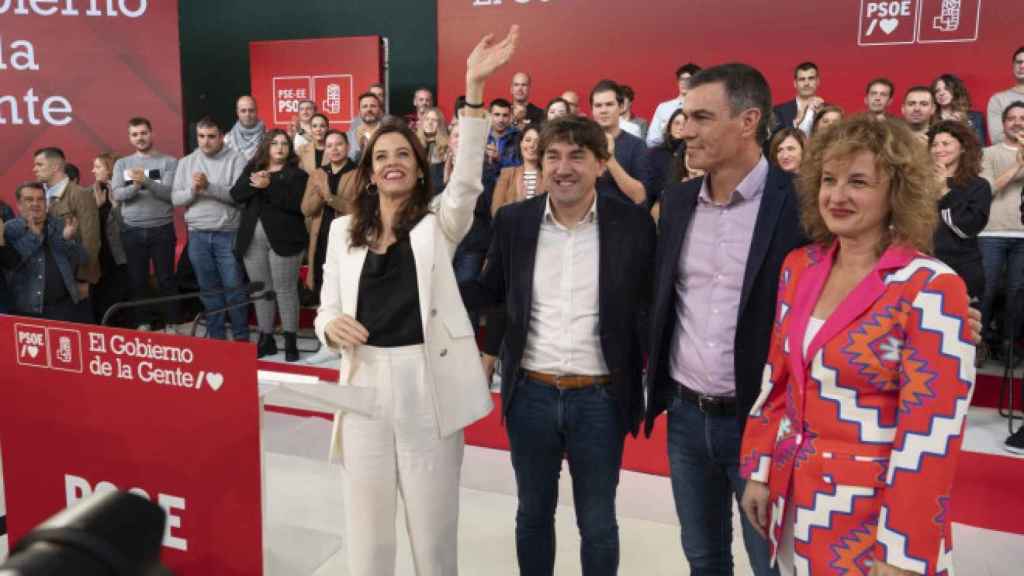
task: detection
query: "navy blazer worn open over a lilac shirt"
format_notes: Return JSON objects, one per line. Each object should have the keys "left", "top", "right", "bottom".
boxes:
{"left": 644, "top": 165, "right": 807, "bottom": 436}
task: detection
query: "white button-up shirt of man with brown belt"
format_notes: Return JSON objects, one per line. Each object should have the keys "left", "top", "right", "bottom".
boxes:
{"left": 522, "top": 198, "right": 608, "bottom": 376}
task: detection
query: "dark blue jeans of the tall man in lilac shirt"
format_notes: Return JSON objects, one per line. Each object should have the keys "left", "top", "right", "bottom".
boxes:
{"left": 669, "top": 395, "right": 778, "bottom": 576}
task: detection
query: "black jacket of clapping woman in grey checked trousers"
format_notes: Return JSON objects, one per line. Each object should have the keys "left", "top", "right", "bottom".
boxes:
{"left": 231, "top": 164, "right": 309, "bottom": 258}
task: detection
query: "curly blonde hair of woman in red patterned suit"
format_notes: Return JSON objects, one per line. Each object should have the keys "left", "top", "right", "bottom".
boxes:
{"left": 798, "top": 114, "right": 940, "bottom": 254}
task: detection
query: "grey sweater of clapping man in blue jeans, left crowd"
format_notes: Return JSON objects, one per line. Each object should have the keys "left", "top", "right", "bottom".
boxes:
{"left": 171, "top": 146, "right": 246, "bottom": 232}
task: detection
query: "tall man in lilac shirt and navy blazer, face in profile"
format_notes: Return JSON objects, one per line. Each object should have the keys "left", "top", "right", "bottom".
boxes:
{"left": 645, "top": 64, "right": 806, "bottom": 576}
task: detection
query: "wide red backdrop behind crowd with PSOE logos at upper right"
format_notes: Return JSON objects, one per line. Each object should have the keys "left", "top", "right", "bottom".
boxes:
{"left": 437, "top": 0, "right": 1024, "bottom": 126}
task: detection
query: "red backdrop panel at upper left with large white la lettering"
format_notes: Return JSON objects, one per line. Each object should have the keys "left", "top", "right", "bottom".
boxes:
{"left": 0, "top": 0, "right": 183, "bottom": 206}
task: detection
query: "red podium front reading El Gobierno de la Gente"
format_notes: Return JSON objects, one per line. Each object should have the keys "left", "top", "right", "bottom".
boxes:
{"left": 0, "top": 315, "right": 263, "bottom": 576}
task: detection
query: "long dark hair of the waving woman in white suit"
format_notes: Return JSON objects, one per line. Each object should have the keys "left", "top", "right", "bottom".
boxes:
{"left": 350, "top": 117, "right": 434, "bottom": 247}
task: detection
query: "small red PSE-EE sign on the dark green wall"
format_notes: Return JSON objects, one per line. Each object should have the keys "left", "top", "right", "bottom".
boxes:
{"left": 249, "top": 36, "right": 382, "bottom": 131}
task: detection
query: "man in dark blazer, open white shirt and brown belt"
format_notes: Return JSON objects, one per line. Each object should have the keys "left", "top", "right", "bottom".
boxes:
{"left": 464, "top": 117, "right": 656, "bottom": 576}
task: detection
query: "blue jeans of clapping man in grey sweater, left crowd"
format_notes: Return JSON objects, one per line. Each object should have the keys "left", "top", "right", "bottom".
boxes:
{"left": 188, "top": 230, "right": 249, "bottom": 341}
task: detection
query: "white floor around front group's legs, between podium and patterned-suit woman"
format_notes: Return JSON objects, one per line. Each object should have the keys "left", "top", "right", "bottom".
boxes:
{"left": 264, "top": 413, "right": 751, "bottom": 576}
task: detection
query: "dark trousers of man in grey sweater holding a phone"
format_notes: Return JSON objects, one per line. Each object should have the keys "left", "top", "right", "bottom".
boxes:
{"left": 121, "top": 223, "right": 178, "bottom": 326}
